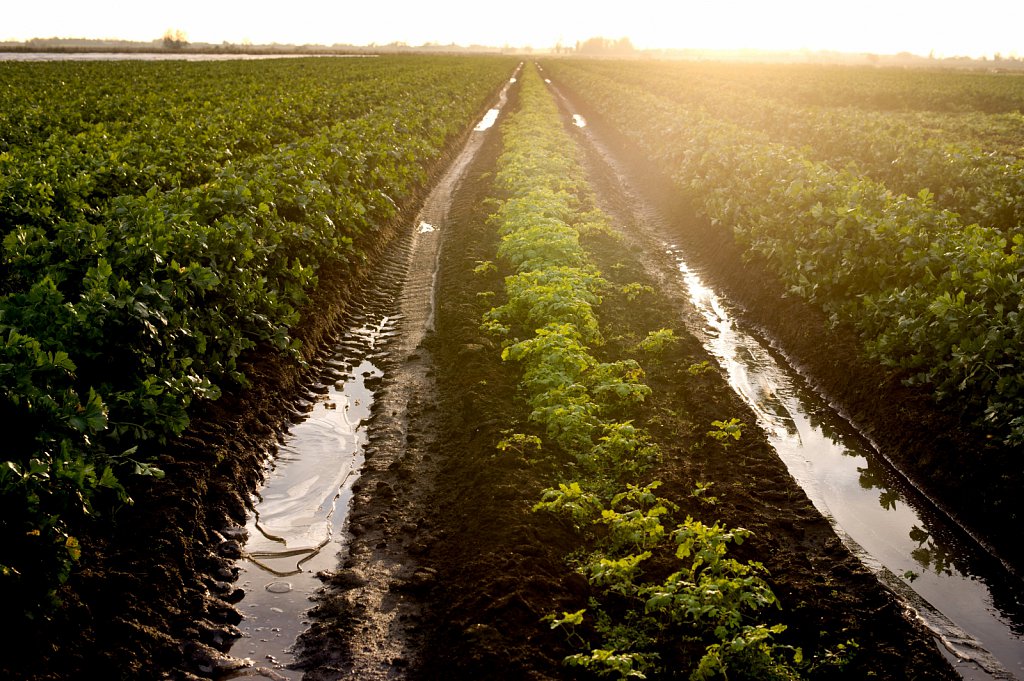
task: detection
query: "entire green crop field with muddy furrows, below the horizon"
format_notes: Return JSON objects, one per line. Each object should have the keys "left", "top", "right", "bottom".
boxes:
{"left": 0, "top": 55, "right": 1024, "bottom": 681}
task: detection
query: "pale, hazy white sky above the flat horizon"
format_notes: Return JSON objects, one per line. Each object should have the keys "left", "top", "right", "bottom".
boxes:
{"left": 0, "top": 0, "right": 1024, "bottom": 56}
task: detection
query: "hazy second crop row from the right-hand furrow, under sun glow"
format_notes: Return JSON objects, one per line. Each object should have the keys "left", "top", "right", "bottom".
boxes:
{"left": 561, "top": 62, "right": 1024, "bottom": 235}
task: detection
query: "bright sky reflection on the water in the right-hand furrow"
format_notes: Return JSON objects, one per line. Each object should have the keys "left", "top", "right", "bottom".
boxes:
{"left": 670, "top": 250, "right": 1024, "bottom": 679}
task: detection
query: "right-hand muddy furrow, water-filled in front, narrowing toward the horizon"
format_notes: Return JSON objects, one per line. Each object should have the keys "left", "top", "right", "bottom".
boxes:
{"left": 549, "top": 76, "right": 1024, "bottom": 679}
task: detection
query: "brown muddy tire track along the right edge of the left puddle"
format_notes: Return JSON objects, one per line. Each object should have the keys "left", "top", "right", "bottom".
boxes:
{"left": 297, "top": 67, "right": 515, "bottom": 679}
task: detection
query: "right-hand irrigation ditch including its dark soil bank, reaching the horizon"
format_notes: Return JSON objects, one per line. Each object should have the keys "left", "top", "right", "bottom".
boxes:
{"left": 547, "top": 66, "right": 1024, "bottom": 680}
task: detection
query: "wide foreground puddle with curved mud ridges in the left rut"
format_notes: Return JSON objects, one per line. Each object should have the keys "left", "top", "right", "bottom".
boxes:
{"left": 227, "top": 315, "right": 394, "bottom": 679}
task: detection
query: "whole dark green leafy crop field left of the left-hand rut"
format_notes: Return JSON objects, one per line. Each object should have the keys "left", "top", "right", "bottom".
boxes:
{"left": 0, "top": 58, "right": 512, "bottom": 619}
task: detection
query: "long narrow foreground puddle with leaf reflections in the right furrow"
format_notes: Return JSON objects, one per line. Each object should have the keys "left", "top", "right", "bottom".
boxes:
{"left": 669, "top": 253, "right": 1024, "bottom": 680}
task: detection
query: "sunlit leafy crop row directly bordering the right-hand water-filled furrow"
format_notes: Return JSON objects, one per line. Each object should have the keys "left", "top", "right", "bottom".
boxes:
{"left": 547, "top": 61, "right": 1024, "bottom": 446}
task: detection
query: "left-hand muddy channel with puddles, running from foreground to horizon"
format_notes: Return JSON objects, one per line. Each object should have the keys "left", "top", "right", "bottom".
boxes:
{"left": 224, "top": 69, "right": 518, "bottom": 681}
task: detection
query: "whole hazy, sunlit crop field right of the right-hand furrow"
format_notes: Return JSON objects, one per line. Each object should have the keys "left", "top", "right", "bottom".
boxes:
{"left": 544, "top": 58, "right": 1024, "bottom": 445}
